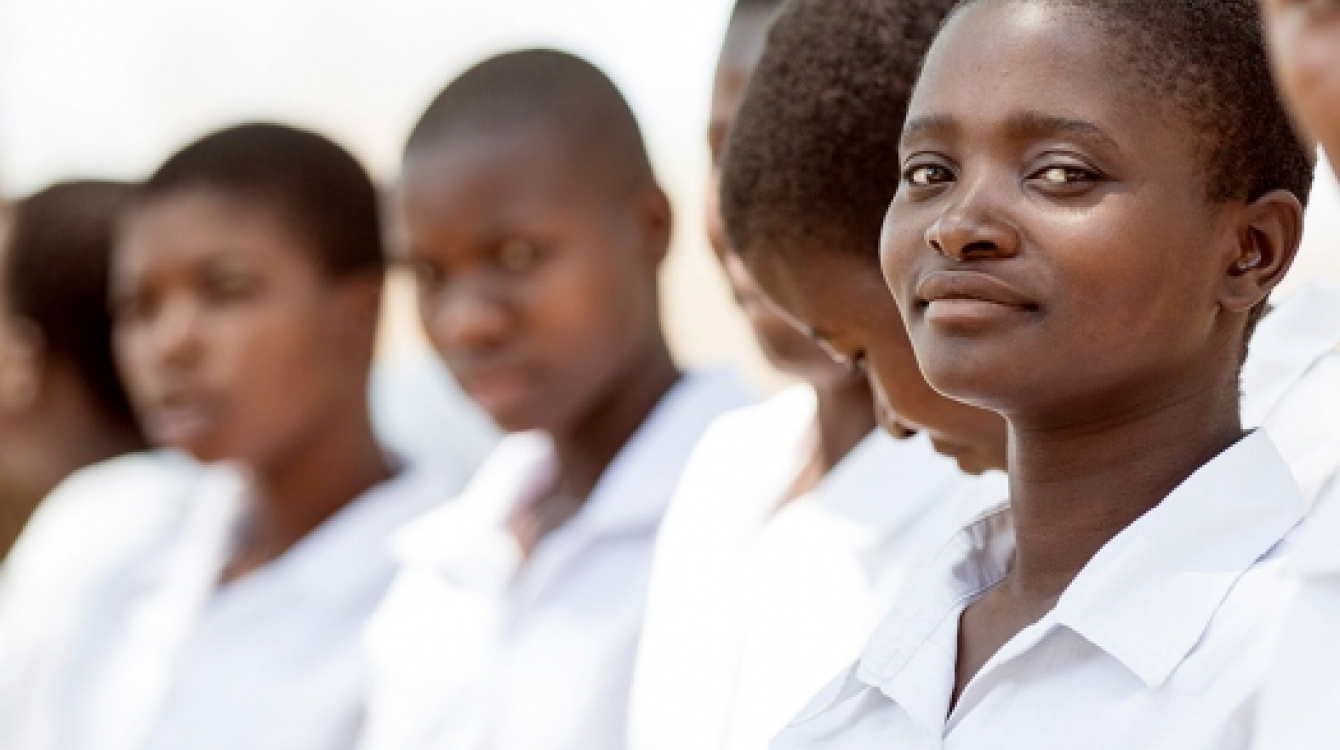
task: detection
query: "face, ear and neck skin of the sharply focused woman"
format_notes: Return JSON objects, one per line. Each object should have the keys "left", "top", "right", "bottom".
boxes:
{"left": 883, "top": 0, "right": 1302, "bottom": 703}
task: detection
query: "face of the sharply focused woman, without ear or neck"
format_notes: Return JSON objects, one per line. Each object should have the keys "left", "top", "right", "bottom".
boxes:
{"left": 883, "top": 1, "right": 1270, "bottom": 425}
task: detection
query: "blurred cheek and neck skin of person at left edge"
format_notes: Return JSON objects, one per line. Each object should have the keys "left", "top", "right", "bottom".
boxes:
{"left": 0, "top": 208, "right": 143, "bottom": 558}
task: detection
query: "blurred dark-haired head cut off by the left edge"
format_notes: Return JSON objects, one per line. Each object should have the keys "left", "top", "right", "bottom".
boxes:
{"left": 0, "top": 182, "right": 139, "bottom": 437}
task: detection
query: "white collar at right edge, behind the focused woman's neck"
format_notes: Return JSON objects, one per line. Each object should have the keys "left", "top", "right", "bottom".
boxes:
{"left": 1242, "top": 280, "right": 1340, "bottom": 427}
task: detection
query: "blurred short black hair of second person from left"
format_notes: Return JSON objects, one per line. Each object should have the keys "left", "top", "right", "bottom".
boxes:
{"left": 139, "top": 123, "right": 386, "bottom": 279}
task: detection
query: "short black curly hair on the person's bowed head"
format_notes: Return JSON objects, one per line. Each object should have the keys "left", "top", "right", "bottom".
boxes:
{"left": 721, "top": 0, "right": 955, "bottom": 261}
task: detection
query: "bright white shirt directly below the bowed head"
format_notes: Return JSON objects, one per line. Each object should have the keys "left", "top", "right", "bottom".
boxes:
{"left": 628, "top": 386, "right": 1005, "bottom": 750}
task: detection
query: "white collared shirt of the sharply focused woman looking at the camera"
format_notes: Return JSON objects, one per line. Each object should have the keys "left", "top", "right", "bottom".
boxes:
{"left": 772, "top": 433, "right": 1307, "bottom": 750}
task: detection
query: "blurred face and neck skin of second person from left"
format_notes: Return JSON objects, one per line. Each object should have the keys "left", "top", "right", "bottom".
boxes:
{"left": 113, "top": 190, "right": 395, "bottom": 583}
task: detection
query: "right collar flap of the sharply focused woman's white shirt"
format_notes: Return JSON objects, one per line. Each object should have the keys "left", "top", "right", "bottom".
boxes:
{"left": 1056, "top": 431, "right": 1307, "bottom": 688}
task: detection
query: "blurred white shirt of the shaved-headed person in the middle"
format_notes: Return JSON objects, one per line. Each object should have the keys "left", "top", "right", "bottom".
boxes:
{"left": 363, "top": 375, "right": 748, "bottom": 750}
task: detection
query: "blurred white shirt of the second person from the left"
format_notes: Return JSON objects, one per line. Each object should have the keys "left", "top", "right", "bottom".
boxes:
{"left": 7, "top": 458, "right": 460, "bottom": 750}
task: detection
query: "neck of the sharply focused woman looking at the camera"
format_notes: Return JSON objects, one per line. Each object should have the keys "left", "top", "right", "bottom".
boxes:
{"left": 1008, "top": 361, "right": 1242, "bottom": 600}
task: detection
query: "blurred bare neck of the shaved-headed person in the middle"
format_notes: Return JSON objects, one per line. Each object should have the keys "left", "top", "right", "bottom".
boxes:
{"left": 555, "top": 333, "right": 679, "bottom": 501}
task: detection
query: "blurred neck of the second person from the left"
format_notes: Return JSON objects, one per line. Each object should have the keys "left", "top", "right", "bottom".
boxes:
{"left": 224, "top": 399, "right": 395, "bottom": 581}
